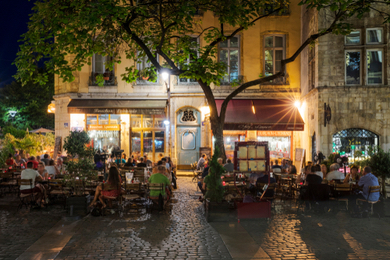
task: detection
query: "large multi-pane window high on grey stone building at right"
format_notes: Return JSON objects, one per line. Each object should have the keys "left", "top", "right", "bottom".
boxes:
{"left": 345, "top": 28, "right": 384, "bottom": 85}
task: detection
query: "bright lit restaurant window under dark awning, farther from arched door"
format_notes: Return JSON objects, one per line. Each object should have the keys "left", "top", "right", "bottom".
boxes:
{"left": 87, "top": 114, "right": 121, "bottom": 153}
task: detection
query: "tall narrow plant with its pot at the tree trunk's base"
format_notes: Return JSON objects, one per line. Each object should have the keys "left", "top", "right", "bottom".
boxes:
{"left": 204, "top": 147, "right": 230, "bottom": 222}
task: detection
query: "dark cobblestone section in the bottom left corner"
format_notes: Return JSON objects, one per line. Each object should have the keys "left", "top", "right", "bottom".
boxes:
{"left": 0, "top": 194, "right": 64, "bottom": 260}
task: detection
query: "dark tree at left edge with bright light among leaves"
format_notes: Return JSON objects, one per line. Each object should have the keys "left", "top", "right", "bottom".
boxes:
{"left": 0, "top": 69, "right": 54, "bottom": 130}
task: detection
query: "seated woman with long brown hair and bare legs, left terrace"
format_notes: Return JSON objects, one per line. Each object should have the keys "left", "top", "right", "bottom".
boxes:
{"left": 89, "top": 167, "right": 122, "bottom": 208}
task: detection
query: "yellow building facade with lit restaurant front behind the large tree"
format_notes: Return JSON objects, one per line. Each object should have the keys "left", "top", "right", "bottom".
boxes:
{"left": 54, "top": 0, "right": 301, "bottom": 168}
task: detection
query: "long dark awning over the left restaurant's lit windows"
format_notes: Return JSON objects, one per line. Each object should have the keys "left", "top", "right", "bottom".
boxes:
{"left": 68, "top": 99, "right": 167, "bottom": 115}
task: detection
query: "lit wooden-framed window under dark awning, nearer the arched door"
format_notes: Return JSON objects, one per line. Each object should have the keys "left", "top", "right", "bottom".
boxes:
{"left": 130, "top": 115, "right": 165, "bottom": 161}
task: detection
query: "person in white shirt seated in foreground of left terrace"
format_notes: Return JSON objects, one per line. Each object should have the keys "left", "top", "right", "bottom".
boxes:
{"left": 20, "top": 162, "right": 46, "bottom": 207}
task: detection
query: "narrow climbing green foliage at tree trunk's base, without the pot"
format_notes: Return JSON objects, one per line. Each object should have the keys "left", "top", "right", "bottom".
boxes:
{"left": 204, "top": 147, "right": 226, "bottom": 202}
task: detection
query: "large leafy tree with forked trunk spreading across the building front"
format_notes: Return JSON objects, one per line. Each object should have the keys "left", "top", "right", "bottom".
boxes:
{"left": 15, "top": 0, "right": 389, "bottom": 156}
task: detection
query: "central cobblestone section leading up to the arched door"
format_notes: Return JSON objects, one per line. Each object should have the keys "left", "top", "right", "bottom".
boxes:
{"left": 56, "top": 177, "right": 231, "bottom": 259}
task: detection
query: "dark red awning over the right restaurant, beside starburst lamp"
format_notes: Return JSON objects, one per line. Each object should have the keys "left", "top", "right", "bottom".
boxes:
{"left": 215, "top": 99, "right": 305, "bottom": 131}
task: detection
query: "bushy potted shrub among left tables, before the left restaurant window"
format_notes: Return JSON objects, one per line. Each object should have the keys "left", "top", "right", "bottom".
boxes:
{"left": 64, "top": 131, "right": 97, "bottom": 196}
